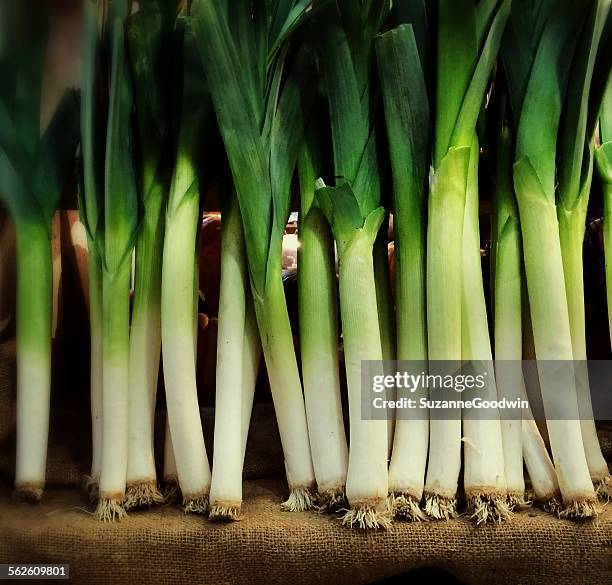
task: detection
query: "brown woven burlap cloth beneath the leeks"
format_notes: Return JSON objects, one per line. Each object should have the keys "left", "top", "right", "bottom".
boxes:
{"left": 0, "top": 344, "right": 612, "bottom": 585}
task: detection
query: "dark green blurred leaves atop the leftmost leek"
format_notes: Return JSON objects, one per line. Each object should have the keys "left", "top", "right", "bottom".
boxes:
{"left": 0, "top": 2, "right": 79, "bottom": 226}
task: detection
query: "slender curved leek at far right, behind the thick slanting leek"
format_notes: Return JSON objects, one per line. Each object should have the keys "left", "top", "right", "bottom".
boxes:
{"left": 557, "top": 0, "right": 612, "bottom": 494}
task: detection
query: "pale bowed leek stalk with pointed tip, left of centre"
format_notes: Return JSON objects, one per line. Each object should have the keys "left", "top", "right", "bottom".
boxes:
{"left": 161, "top": 161, "right": 211, "bottom": 513}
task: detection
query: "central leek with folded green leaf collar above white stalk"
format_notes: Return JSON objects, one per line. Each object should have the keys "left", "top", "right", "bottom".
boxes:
{"left": 317, "top": 2, "right": 391, "bottom": 528}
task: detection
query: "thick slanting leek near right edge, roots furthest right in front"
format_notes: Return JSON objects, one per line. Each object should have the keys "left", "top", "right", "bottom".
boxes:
{"left": 504, "top": 0, "right": 596, "bottom": 517}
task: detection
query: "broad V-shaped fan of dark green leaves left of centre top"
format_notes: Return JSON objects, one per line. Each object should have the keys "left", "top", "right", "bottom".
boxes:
{"left": 192, "top": 0, "right": 310, "bottom": 294}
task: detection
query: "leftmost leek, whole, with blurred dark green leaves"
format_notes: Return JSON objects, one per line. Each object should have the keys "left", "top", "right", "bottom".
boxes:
{"left": 0, "top": 0, "right": 78, "bottom": 500}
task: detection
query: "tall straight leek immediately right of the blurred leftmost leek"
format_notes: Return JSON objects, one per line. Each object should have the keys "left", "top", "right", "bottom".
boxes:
{"left": 79, "top": 1, "right": 138, "bottom": 520}
